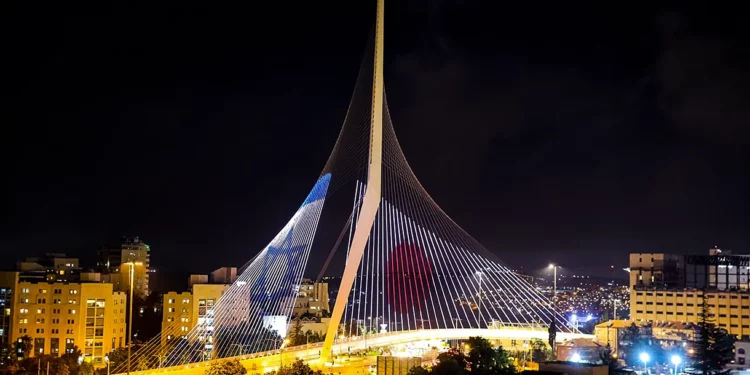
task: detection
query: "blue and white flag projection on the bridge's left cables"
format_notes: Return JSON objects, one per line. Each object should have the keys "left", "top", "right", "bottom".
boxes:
{"left": 166, "top": 174, "right": 331, "bottom": 366}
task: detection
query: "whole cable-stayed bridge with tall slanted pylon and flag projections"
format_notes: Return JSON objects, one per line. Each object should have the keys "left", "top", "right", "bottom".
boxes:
{"left": 113, "top": 0, "right": 582, "bottom": 373}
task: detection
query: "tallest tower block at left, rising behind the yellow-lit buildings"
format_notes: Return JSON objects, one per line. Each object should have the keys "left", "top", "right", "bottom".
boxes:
{"left": 96, "top": 237, "right": 151, "bottom": 298}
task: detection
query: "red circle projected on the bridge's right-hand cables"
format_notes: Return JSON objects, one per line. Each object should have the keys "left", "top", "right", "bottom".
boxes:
{"left": 385, "top": 242, "right": 432, "bottom": 314}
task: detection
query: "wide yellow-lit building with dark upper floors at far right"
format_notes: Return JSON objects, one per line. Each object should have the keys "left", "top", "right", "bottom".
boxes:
{"left": 630, "top": 249, "right": 750, "bottom": 339}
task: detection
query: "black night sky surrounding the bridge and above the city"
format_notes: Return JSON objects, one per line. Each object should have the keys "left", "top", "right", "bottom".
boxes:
{"left": 0, "top": 1, "right": 750, "bottom": 288}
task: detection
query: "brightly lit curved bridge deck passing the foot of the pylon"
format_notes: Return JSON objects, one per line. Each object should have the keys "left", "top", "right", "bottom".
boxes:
{"left": 117, "top": 328, "right": 594, "bottom": 375}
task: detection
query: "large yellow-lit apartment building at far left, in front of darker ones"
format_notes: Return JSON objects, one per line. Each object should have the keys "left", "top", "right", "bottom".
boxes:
{"left": 5, "top": 281, "right": 127, "bottom": 365}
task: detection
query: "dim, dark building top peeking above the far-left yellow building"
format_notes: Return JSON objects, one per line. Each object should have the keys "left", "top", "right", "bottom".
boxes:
{"left": 18, "top": 253, "right": 81, "bottom": 282}
